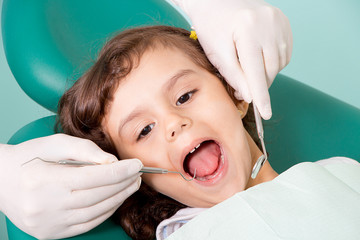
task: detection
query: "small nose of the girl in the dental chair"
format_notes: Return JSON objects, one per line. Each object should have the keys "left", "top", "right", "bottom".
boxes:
{"left": 166, "top": 114, "right": 192, "bottom": 142}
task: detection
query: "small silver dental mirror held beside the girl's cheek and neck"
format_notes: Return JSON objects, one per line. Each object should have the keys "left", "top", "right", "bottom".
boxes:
{"left": 251, "top": 104, "right": 267, "bottom": 179}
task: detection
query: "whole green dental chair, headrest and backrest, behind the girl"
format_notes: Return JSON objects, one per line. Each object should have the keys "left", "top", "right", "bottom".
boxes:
{"left": 2, "top": 0, "right": 360, "bottom": 240}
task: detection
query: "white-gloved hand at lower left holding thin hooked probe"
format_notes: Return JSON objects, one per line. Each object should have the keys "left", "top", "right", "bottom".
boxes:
{"left": 0, "top": 134, "right": 142, "bottom": 239}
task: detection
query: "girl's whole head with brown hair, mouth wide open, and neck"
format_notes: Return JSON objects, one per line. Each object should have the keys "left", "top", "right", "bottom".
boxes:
{"left": 59, "top": 26, "right": 277, "bottom": 239}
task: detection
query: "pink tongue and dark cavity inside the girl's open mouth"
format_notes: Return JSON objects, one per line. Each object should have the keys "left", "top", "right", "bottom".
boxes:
{"left": 186, "top": 141, "right": 221, "bottom": 177}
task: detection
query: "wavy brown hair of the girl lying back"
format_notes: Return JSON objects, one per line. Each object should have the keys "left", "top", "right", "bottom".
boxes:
{"left": 58, "top": 26, "right": 259, "bottom": 239}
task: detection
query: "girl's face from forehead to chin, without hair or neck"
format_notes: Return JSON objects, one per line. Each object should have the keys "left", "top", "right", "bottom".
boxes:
{"left": 103, "top": 48, "right": 252, "bottom": 207}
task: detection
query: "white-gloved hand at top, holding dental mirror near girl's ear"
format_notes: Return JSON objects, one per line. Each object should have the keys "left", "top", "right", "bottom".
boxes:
{"left": 172, "top": 0, "right": 292, "bottom": 119}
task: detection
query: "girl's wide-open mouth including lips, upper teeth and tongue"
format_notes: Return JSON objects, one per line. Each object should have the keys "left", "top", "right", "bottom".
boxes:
{"left": 183, "top": 140, "right": 224, "bottom": 182}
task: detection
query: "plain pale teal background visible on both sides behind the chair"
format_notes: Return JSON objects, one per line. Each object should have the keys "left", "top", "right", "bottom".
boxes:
{"left": 0, "top": 0, "right": 360, "bottom": 240}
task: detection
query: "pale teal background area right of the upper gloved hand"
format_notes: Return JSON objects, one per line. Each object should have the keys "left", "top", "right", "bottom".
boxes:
{"left": 265, "top": 0, "right": 360, "bottom": 108}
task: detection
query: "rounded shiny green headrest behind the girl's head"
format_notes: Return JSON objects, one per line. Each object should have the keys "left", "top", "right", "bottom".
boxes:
{"left": 2, "top": 0, "right": 189, "bottom": 112}
